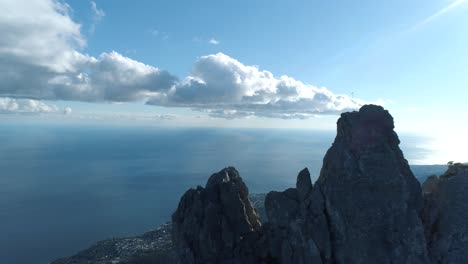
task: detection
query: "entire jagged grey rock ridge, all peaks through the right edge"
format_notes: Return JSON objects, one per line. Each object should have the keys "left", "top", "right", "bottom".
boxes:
{"left": 173, "top": 105, "right": 468, "bottom": 264}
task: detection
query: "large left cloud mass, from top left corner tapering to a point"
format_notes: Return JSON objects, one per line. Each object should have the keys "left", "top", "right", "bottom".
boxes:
{"left": 0, "top": 0, "right": 177, "bottom": 102}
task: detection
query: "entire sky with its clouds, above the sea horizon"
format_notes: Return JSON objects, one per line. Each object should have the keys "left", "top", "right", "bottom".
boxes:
{"left": 0, "top": 0, "right": 468, "bottom": 163}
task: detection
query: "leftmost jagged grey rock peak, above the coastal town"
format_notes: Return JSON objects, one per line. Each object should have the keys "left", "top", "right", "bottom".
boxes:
{"left": 172, "top": 167, "right": 261, "bottom": 263}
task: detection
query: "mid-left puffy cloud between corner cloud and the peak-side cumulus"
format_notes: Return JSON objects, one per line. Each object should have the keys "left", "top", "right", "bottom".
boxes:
{"left": 52, "top": 51, "right": 177, "bottom": 102}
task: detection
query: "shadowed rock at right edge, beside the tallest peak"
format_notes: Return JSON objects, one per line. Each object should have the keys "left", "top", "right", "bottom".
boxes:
{"left": 423, "top": 166, "right": 468, "bottom": 264}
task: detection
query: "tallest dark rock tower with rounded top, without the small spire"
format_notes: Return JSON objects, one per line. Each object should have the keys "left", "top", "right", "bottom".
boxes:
{"left": 317, "top": 105, "right": 427, "bottom": 263}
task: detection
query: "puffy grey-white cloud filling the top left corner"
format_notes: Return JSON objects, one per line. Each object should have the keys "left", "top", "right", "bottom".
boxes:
{"left": 0, "top": 0, "right": 86, "bottom": 72}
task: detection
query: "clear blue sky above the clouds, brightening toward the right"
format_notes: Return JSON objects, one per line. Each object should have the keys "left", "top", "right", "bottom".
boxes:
{"left": 69, "top": 0, "right": 468, "bottom": 107}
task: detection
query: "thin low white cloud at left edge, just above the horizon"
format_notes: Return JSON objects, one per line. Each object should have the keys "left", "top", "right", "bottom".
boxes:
{"left": 0, "top": 97, "right": 58, "bottom": 114}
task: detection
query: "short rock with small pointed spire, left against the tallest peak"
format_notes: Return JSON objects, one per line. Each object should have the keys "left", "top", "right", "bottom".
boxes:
{"left": 265, "top": 169, "right": 331, "bottom": 263}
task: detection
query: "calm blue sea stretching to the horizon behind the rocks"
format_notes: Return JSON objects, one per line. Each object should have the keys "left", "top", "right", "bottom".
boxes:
{"left": 0, "top": 125, "right": 438, "bottom": 264}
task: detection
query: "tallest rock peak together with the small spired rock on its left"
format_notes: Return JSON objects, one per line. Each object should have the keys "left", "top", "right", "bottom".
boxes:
{"left": 265, "top": 105, "right": 427, "bottom": 263}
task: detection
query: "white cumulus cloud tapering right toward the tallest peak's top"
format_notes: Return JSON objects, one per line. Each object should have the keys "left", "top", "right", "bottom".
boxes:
{"left": 148, "top": 53, "right": 364, "bottom": 118}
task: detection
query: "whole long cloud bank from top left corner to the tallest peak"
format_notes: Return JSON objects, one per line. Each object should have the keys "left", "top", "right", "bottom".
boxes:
{"left": 0, "top": 0, "right": 364, "bottom": 118}
